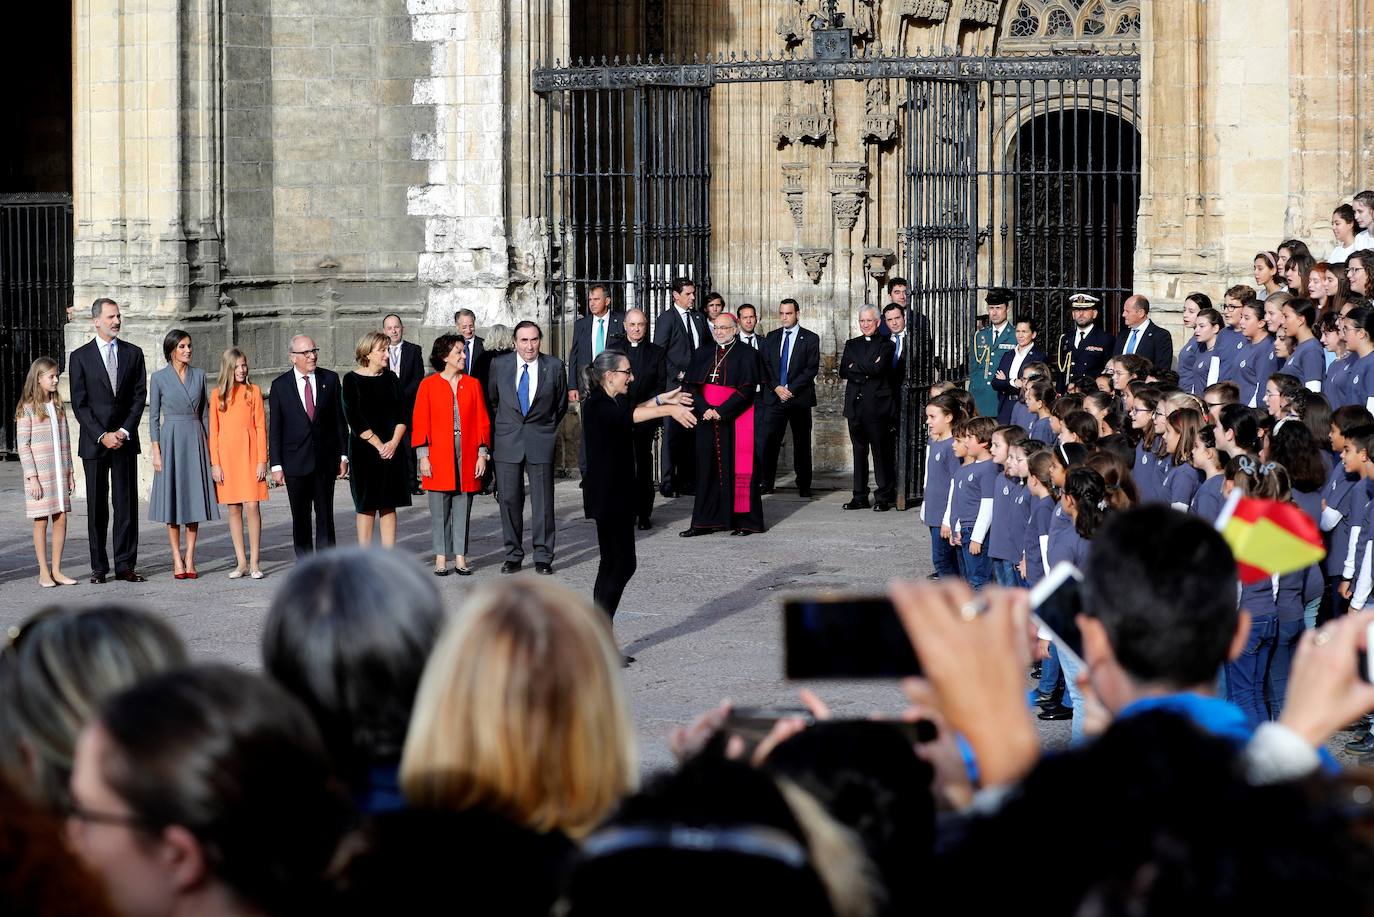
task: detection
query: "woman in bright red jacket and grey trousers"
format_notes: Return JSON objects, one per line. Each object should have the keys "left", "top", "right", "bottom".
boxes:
{"left": 411, "top": 334, "right": 492, "bottom": 576}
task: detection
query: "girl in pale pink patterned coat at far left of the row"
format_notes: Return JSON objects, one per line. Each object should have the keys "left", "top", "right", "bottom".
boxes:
{"left": 14, "top": 356, "right": 77, "bottom": 588}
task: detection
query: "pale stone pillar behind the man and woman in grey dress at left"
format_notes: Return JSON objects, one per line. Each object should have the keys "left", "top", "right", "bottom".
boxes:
{"left": 66, "top": 0, "right": 224, "bottom": 503}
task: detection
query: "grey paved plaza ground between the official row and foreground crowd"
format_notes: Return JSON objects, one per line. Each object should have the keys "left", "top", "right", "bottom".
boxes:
{"left": 0, "top": 462, "right": 1348, "bottom": 771}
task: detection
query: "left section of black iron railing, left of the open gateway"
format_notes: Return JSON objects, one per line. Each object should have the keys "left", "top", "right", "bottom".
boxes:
{"left": 540, "top": 80, "right": 710, "bottom": 352}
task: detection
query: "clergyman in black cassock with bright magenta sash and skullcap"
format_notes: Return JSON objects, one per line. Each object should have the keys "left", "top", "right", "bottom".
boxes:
{"left": 679, "top": 312, "right": 765, "bottom": 538}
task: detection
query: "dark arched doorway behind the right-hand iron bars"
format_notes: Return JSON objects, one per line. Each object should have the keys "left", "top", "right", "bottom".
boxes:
{"left": 1010, "top": 109, "right": 1140, "bottom": 349}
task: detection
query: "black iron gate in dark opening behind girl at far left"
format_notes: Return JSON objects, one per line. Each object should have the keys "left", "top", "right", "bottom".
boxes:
{"left": 0, "top": 194, "right": 71, "bottom": 454}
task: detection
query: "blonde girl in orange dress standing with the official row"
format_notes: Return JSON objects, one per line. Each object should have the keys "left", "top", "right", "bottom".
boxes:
{"left": 210, "top": 346, "right": 267, "bottom": 580}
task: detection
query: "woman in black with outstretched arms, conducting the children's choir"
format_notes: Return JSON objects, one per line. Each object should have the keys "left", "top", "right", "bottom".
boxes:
{"left": 583, "top": 351, "right": 697, "bottom": 663}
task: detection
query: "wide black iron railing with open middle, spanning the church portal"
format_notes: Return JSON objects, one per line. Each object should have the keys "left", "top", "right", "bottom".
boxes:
{"left": 532, "top": 45, "right": 1140, "bottom": 505}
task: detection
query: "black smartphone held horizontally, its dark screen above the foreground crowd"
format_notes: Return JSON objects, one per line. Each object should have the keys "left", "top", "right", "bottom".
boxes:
{"left": 783, "top": 595, "right": 921, "bottom": 679}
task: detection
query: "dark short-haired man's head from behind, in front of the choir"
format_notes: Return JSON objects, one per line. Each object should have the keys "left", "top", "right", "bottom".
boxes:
{"left": 1080, "top": 506, "right": 1249, "bottom": 712}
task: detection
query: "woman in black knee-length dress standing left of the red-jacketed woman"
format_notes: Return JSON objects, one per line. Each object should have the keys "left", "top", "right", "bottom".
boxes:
{"left": 344, "top": 331, "right": 411, "bottom": 547}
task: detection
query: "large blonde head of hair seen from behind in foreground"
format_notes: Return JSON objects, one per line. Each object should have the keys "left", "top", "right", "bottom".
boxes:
{"left": 401, "top": 577, "right": 636, "bottom": 839}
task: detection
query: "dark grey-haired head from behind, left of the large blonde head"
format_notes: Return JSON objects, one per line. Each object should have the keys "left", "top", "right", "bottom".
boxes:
{"left": 262, "top": 549, "right": 447, "bottom": 814}
